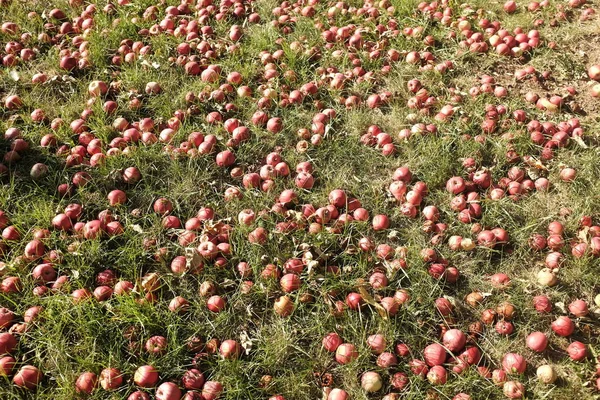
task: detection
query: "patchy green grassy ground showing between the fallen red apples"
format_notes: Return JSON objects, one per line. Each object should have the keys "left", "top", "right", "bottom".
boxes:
{"left": 0, "top": 0, "right": 600, "bottom": 400}
